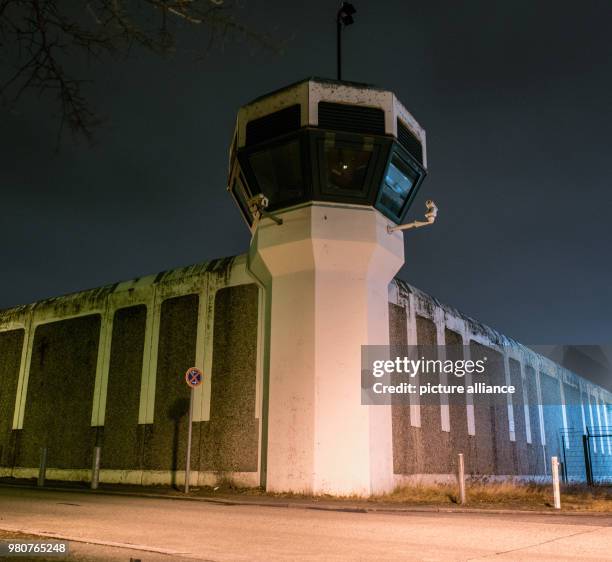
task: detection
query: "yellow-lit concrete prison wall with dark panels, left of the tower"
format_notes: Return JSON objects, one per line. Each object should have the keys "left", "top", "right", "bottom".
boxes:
{"left": 0, "top": 258, "right": 259, "bottom": 485}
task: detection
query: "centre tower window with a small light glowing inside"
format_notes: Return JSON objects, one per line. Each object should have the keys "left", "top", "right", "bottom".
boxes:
{"left": 324, "top": 146, "right": 372, "bottom": 193}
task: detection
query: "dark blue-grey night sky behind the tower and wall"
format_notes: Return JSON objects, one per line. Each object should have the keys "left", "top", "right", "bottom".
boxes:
{"left": 0, "top": 0, "right": 612, "bottom": 345}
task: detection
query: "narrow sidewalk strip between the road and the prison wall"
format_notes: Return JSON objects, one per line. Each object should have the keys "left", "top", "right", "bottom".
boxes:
{"left": 0, "top": 478, "right": 612, "bottom": 517}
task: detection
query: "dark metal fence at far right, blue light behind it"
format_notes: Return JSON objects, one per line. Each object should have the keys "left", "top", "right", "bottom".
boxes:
{"left": 559, "top": 426, "right": 612, "bottom": 485}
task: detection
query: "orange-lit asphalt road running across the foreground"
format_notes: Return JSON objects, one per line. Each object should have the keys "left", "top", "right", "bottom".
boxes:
{"left": 0, "top": 488, "right": 612, "bottom": 562}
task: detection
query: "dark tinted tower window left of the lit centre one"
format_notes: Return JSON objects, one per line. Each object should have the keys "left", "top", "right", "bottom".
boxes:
{"left": 249, "top": 139, "right": 304, "bottom": 205}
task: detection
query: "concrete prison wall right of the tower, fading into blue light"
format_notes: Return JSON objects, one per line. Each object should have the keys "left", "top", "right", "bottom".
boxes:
{"left": 389, "top": 280, "right": 612, "bottom": 484}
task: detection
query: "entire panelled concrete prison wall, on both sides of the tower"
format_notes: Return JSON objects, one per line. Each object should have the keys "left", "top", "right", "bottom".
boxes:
{"left": 0, "top": 256, "right": 612, "bottom": 486}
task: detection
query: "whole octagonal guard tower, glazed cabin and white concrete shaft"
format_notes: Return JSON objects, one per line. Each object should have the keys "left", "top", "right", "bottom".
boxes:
{"left": 228, "top": 78, "right": 427, "bottom": 495}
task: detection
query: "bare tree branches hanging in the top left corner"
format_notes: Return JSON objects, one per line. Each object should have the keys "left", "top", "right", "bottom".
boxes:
{"left": 0, "top": 0, "right": 279, "bottom": 141}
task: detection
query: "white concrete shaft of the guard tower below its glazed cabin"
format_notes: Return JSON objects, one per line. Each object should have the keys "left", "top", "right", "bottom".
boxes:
{"left": 251, "top": 203, "right": 404, "bottom": 495}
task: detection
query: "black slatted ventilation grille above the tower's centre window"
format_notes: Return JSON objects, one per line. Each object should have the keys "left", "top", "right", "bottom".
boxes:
{"left": 319, "top": 101, "right": 385, "bottom": 135}
